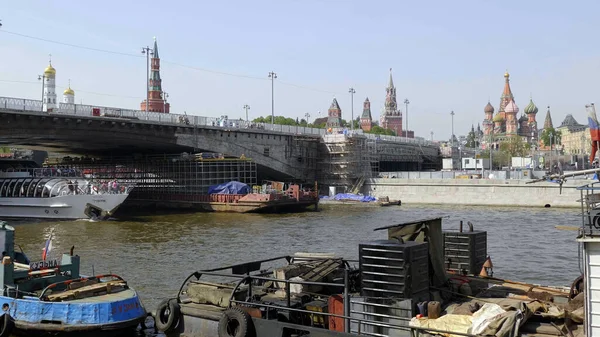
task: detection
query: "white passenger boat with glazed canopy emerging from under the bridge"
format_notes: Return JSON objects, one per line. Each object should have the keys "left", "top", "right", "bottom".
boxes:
{"left": 0, "top": 161, "right": 132, "bottom": 220}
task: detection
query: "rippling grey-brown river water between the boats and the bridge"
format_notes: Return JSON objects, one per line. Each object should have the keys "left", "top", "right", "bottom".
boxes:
{"left": 11, "top": 205, "right": 581, "bottom": 332}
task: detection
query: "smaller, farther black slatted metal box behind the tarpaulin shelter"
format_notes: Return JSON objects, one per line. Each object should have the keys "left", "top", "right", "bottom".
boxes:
{"left": 443, "top": 231, "right": 487, "bottom": 275}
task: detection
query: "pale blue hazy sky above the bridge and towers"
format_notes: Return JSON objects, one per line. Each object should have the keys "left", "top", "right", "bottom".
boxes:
{"left": 0, "top": 0, "right": 600, "bottom": 139}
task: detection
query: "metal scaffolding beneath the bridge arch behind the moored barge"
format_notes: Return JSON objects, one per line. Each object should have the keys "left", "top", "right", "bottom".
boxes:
{"left": 45, "top": 153, "right": 257, "bottom": 202}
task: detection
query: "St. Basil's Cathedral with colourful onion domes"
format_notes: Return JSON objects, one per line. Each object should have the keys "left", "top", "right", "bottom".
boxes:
{"left": 483, "top": 72, "right": 538, "bottom": 144}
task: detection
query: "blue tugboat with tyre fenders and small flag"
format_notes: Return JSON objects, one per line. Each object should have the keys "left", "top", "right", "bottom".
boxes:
{"left": 0, "top": 221, "right": 147, "bottom": 337}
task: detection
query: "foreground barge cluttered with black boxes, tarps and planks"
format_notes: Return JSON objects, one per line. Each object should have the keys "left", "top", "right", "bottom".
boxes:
{"left": 154, "top": 209, "right": 584, "bottom": 337}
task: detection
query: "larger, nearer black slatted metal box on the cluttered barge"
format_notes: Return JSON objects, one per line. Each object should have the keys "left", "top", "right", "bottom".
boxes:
{"left": 359, "top": 240, "right": 429, "bottom": 298}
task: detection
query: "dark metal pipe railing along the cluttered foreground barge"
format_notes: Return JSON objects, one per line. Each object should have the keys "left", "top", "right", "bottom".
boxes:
{"left": 177, "top": 256, "right": 476, "bottom": 337}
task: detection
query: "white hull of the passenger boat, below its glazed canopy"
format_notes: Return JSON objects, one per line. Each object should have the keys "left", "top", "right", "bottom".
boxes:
{"left": 0, "top": 193, "right": 129, "bottom": 220}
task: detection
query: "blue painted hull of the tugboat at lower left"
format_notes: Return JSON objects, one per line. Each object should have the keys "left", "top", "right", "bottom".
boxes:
{"left": 0, "top": 288, "right": 147, "bottom": 335}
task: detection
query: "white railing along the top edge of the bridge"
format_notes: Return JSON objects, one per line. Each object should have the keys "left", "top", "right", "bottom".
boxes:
{"left": 0, "top": 97, "right": 433, "bottom": 145}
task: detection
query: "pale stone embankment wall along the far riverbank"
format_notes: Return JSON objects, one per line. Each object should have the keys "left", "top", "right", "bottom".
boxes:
{"left": 363, "top": 178, "right": 589, "bottom": 207}
